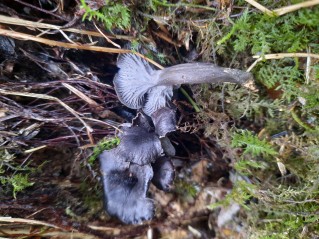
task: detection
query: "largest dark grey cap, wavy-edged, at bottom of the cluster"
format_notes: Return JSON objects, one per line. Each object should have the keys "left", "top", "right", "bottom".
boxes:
{"left": 100, "top": 149, "right": 154, "bottom": 224}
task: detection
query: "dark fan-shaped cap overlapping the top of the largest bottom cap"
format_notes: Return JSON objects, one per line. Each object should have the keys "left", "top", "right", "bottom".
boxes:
{"left": 114, "top": 126, "right": 163, "bottom": 165}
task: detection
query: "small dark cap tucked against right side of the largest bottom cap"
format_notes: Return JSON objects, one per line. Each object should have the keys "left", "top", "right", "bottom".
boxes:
{"left": 152, "top": 157, "right": 175, "bottom": 192}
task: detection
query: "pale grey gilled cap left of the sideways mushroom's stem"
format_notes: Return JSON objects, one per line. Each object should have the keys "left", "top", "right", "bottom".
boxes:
{"left": 113, "top": 54, "right": 157, "bottom": 109}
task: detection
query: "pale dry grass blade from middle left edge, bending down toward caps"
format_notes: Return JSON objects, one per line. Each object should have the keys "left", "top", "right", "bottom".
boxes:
{"left": 0, "top": 89, "right": 93, "bottom": 135}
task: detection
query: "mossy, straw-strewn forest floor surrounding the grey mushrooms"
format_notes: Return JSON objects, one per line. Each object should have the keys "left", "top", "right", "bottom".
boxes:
{"left": 0, "top": 0, "right": 319, "bottom": 239}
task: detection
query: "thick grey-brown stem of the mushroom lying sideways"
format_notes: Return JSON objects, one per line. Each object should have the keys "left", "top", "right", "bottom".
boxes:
{"left": 157, "top": 62, "right": 252, "bottom": 85}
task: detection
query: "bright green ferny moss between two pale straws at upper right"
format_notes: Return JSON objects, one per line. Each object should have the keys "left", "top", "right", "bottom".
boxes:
{"left": 217, "top": 7, "right": 319, "bottom": 55}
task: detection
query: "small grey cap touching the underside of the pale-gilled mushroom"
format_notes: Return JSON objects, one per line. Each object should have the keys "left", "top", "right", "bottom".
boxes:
{"left": 152, "top": 107, "right": 176, "bottom": 138}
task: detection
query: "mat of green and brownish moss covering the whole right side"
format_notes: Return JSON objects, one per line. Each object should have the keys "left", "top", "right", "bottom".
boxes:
{"left": 192, "top": 1, "right": 319, "bottom": 236}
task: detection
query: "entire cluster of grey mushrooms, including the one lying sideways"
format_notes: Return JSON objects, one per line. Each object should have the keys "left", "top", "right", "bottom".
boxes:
{"left": 99, "top": 54, "right": 251, "bottom": 224}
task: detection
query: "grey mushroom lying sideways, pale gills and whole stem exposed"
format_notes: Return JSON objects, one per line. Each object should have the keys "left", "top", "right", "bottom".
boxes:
{"left": 114, "top": 53, "right": 251, "bottom": 116}
